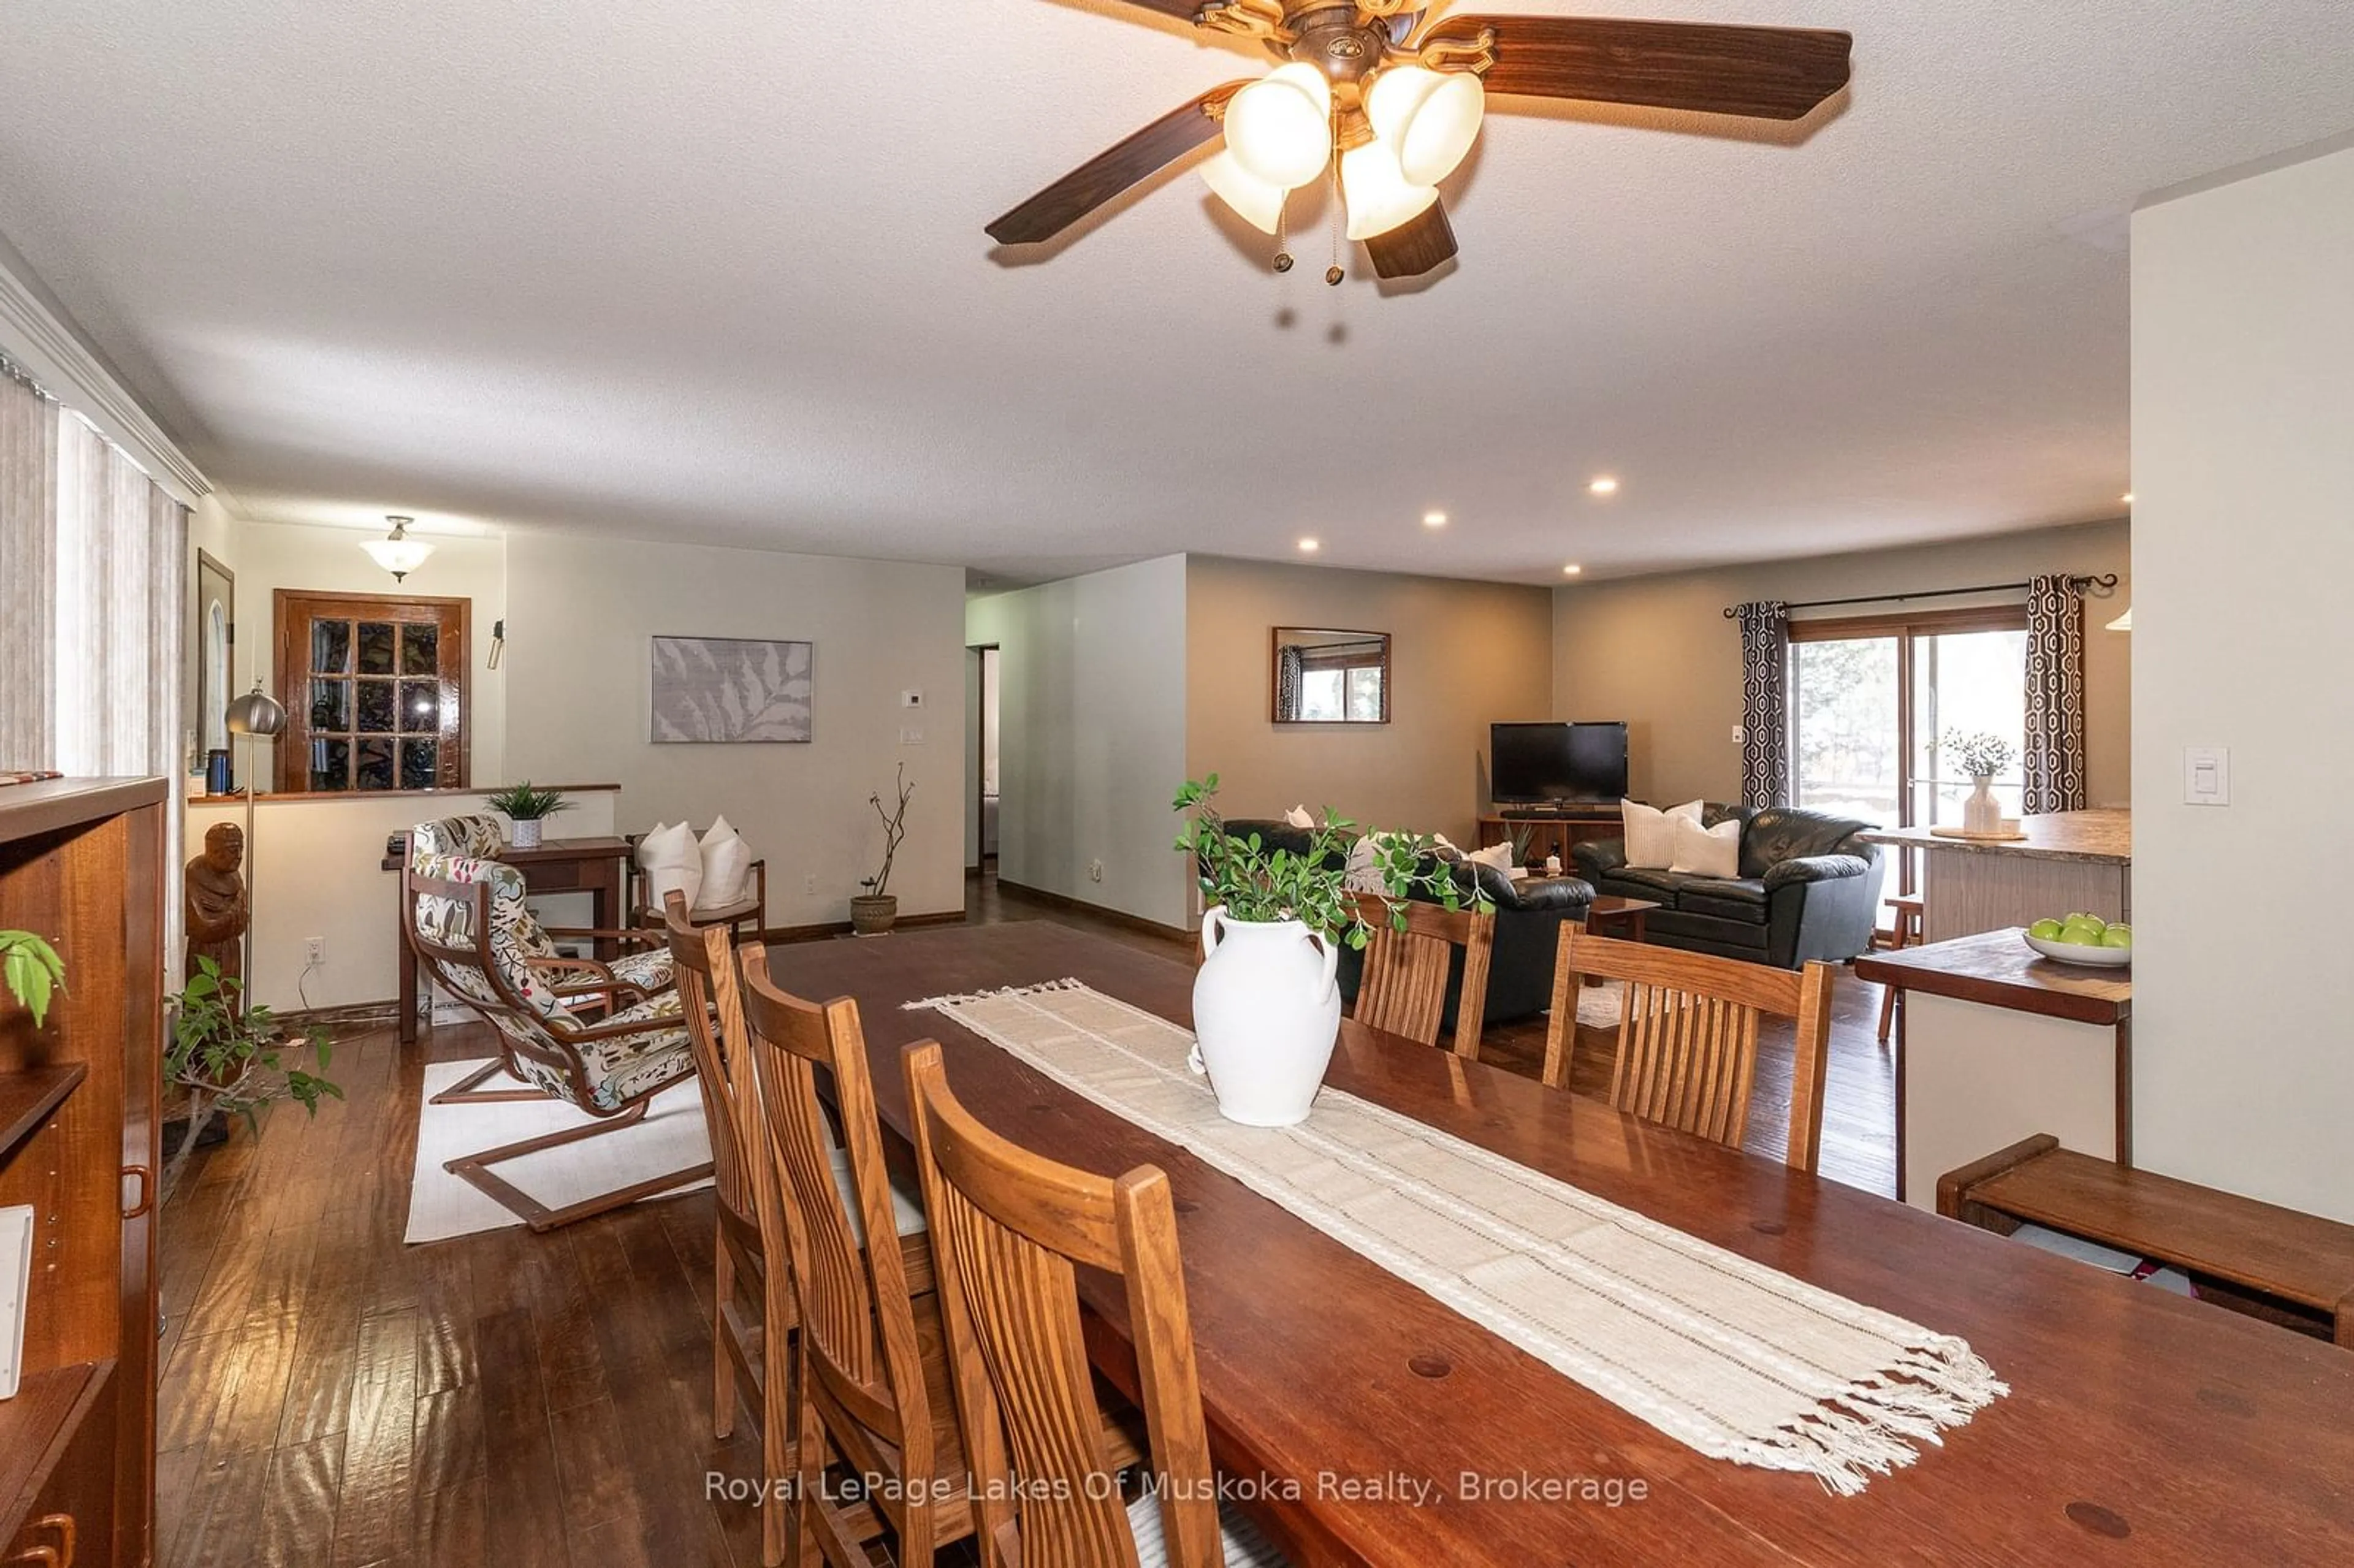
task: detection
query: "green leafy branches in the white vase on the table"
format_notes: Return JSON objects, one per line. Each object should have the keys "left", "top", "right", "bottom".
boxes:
{"left": 1170, "top": 772, "right": 1493, "bottom": 946}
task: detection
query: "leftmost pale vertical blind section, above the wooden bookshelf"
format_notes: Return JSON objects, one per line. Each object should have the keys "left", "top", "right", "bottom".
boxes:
{"left": 0, "top": 360, "right": 56, "bottom": 770}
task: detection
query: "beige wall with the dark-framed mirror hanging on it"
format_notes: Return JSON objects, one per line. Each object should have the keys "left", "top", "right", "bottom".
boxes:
{"left": 1184, "top": 555, "right": 1553, "bottom": 843}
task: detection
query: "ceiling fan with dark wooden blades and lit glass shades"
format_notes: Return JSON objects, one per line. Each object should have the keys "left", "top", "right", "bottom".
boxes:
{"left": 989, "top": 0, "right": 1853, "bottom": 283}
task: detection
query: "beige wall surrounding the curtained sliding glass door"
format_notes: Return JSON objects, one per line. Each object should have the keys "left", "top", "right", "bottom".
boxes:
{"left": 1553, "top": 523, "right": 2133, "bottom": 805}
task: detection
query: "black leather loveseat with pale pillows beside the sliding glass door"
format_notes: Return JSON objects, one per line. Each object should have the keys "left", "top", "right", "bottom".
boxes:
{"left": 1572, "top": 805, "right": 1881, "bottom": 970}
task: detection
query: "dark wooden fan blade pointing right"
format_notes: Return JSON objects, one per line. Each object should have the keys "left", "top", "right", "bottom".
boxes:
{"left": 1420, "top": 17, "right": 1855, "bottom": 120}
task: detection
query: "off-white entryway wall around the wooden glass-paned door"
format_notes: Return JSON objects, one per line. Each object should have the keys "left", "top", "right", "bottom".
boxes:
{"left": 232, "top": 523, "right": 508, "bottom": 789}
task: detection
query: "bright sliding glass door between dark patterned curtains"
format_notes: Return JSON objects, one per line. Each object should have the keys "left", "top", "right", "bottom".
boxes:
{"left": 1789, "top": 605, "right": 2027, "bottom": 923}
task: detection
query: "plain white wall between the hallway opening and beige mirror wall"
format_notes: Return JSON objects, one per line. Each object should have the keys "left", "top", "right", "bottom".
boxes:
{"left": 965, "top": 555, "right": 1191, "bottom": 927}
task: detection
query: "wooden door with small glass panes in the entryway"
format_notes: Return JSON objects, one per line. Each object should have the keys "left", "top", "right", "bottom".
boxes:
{"left": 275, "top": 588, "right": 473, "bottom": 793}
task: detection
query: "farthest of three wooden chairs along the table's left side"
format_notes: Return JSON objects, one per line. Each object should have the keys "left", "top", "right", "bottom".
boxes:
{"left": 664, "top": 892, "right": 801, "bottom": 1568}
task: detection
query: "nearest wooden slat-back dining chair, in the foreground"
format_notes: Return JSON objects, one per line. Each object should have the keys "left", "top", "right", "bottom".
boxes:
{"left": 904, "top": 1041, "right": 1283, "bottom": 1568}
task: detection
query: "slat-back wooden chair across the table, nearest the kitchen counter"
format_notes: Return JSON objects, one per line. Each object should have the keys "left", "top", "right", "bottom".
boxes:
{"left": 1544, "top": 921, "right": 1832, "bottom": 1173}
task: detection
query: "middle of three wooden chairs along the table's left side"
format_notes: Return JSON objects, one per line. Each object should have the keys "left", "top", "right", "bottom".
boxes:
{"left": 742, "top": 942, "right": 972, "bottom": 1568}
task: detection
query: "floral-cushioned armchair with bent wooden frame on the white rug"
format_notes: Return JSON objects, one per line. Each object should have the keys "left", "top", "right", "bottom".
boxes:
{"left": 400, "top": 817, "right": 711, "bottom": 1231}
